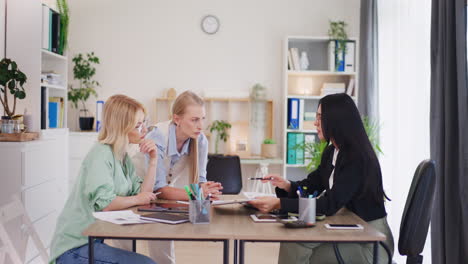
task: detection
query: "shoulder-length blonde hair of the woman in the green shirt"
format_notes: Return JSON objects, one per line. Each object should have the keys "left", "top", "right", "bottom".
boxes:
{"left": 98, "top": 94, "right": 146, "bottom": 161}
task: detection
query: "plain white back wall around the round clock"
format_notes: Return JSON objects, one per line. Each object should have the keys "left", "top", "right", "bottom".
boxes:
{"left": 68, "top": 0, "right": 359, "bottom": 144}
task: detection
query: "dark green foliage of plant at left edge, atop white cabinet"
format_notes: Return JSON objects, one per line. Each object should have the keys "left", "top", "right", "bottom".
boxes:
{"left": 0, "top": 58, "right": 28, "bottom": 118}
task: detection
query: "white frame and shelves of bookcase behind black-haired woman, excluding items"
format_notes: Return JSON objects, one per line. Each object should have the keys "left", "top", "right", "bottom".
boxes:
{"left": 282, "top": 36, "right": 359, "bottom": 180}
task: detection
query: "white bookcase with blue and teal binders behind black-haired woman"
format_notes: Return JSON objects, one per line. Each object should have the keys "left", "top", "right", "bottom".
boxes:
{"left": 281, "top": 36, "right": 358, "bottom": 180}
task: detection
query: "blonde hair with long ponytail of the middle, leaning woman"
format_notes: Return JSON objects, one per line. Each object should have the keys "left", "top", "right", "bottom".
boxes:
{"left": 172, "top": 91, "right": 205, "bottom": 183}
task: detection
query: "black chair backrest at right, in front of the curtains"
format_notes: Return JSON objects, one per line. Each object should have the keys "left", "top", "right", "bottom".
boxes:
{"left": 398, "top": 160, "right": 436, "bottom": 261}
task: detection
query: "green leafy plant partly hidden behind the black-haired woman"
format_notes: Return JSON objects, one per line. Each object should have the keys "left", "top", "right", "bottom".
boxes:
{"left": 295, "top": 117, "right": 383, "bottom": 172}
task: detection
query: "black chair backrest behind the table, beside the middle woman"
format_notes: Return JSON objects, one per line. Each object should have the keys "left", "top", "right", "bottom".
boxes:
{"left": 206, "top": 155, "right": 242, "bottom": 194}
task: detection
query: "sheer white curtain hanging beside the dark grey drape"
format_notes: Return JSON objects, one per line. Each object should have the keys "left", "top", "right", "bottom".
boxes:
{"left": 378, "top": 0, "right": 431, "bottom": 263}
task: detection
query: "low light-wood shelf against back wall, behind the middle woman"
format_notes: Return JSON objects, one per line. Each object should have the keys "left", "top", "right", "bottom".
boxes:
{"left": 154, "top": 97, "right": 274, "bottom": 157}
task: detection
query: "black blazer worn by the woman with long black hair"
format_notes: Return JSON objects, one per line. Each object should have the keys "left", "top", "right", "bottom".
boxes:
{"left": 276, "top": 145, "right": 387, "bottom": 221}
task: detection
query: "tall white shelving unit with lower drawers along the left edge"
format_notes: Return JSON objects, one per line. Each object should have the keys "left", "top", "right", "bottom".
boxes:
{"left": 0, "top": 0, "right": 69, "bottom": 264}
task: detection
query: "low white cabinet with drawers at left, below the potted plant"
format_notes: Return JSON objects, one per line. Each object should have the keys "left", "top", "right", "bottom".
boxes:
{"left": 0, "top": 133, "right": 68, "bottom": 263}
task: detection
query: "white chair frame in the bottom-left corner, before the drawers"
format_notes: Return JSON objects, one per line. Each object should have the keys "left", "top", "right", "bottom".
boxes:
{"left": 0, "top": 195, "right": 49, "bottom": 264}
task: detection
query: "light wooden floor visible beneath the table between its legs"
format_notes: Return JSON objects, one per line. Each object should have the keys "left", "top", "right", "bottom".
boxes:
{"left": 130, "top": 241, "right": 279, "bottom": 264}
